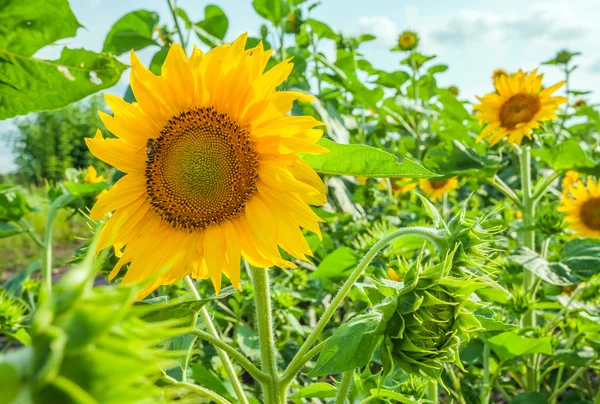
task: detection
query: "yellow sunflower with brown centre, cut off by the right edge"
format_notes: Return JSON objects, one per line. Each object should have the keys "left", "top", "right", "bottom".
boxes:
{"left": 558, "top": 177, "right": 600, "bottom": 238}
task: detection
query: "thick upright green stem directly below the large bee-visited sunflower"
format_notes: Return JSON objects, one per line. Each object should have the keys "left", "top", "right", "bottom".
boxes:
{"left": 251, "top": 267, "right": 286, "bottom": 404}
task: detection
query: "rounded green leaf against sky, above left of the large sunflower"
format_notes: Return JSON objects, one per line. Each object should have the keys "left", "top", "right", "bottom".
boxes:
{"left": 102, "top": 10, "right": 158, "bottom": 56}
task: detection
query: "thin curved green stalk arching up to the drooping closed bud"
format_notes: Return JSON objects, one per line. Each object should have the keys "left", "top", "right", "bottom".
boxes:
{"left": 281, "top": 227, "right": 446, "bottom": 386}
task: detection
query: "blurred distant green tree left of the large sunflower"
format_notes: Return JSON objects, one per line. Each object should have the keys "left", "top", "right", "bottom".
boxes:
{"left": 10, "top": 95, "right": 106, "bottom": 184}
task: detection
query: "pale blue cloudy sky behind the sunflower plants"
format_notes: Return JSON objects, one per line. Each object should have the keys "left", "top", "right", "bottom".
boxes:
{"left": 0, "top": 0, "right": 600, "bottom": 173}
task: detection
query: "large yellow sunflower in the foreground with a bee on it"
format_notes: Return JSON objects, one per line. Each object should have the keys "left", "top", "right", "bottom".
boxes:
{"left": 86, "top": 34, "right": 327, "bottom": 297}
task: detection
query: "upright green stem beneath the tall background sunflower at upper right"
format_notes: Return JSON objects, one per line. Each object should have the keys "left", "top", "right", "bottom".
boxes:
{"left": 519, "top": 146, "right": 537, "bottom": 391}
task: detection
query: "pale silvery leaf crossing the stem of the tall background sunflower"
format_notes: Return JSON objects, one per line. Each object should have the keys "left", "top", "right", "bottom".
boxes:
{"left": 510, "top": 247, "right": 579, "bottom": 286}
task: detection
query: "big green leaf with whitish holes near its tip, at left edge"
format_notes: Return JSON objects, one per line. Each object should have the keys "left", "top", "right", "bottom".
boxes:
{"left": 0, "top": 48, "right": 127, "bottom": 119}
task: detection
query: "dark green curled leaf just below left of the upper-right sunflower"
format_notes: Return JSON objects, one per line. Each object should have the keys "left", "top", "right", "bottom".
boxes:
{"left": 423, "top": 141, "right": 505, "bottom": 178}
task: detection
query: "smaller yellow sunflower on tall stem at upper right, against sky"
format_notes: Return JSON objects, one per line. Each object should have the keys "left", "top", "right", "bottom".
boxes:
{"left": 473, "top": 70, "right": 567, "bottom": 146}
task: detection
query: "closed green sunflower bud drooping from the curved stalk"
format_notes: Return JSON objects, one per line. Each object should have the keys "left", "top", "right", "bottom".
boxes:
{"left": 374, "top": 252, "right": 482, "bottom": 382}
